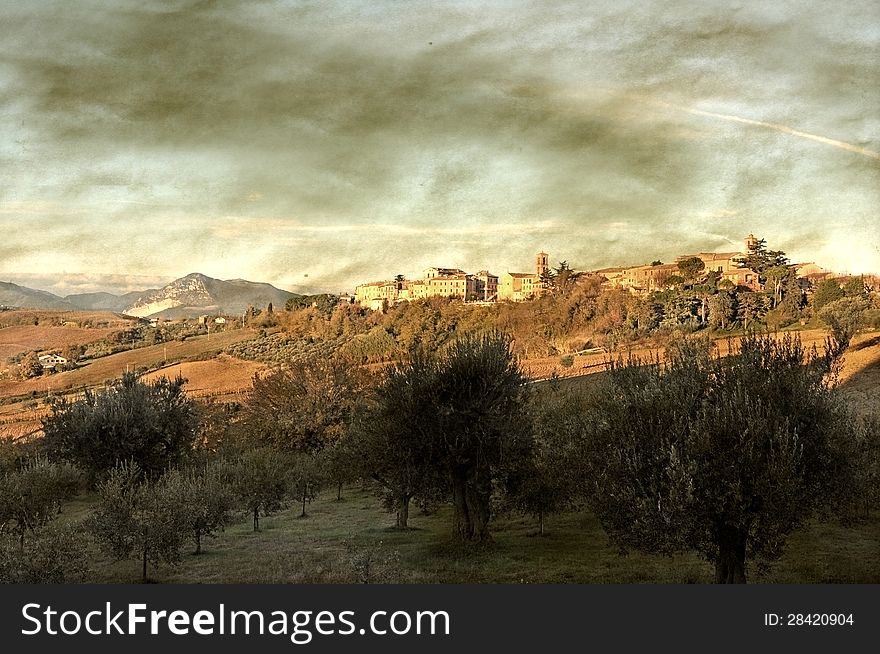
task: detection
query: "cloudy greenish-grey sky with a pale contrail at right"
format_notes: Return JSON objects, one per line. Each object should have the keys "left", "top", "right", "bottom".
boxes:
{"left": 0, "top": 0, "right": 880, "bottom": 295}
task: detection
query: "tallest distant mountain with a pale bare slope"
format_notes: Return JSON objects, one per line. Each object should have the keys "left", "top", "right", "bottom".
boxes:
{"left": 122, "top": 273, "right": 299, "bottom": 318}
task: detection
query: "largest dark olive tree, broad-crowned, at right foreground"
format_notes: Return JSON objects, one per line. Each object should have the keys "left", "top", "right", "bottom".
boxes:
{"left": 584, "top": 336, "right": 854, "bottom": 583}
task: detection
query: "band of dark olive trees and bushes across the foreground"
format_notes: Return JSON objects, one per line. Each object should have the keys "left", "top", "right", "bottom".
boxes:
{"left": 0, "top": 332, "right": 880, "bottom": 582}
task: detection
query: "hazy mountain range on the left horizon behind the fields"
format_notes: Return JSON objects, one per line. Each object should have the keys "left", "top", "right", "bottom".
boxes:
{"left": 0, "top": 273, "right": 300, "bottom": 318}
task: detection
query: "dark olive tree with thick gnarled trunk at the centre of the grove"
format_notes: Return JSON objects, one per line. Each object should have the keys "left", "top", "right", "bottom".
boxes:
{"left": 358, "top": 333, "right": 532, "bottom": 542}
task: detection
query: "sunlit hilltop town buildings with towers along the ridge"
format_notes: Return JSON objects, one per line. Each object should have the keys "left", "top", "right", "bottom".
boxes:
{"left": 354, "top": 234, "right": 830, "bottom": 309}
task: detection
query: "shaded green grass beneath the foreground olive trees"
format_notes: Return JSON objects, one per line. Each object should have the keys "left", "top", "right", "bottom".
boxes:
{"left": 63, "top": 488, "right": 880, "bottom": 584}
